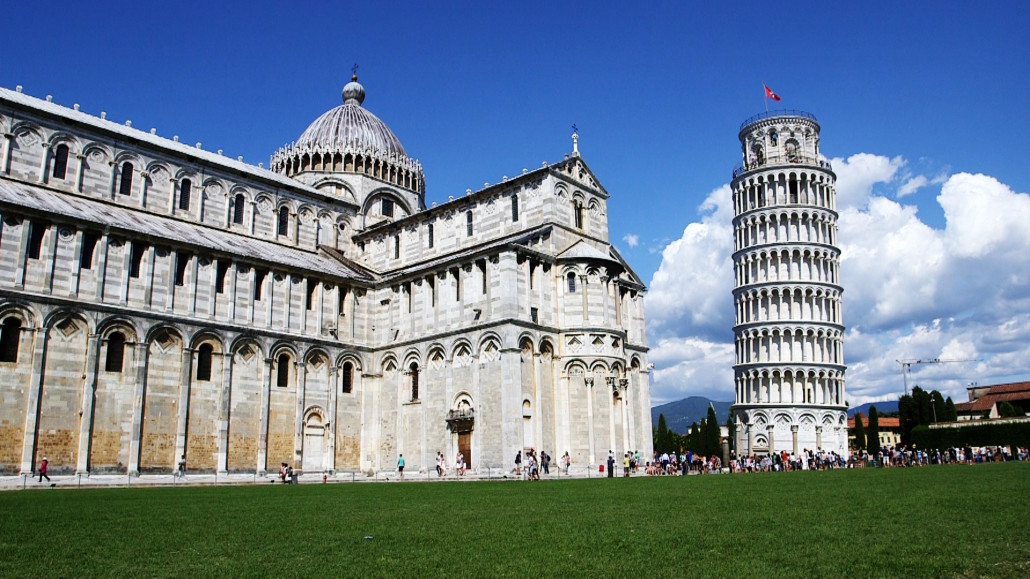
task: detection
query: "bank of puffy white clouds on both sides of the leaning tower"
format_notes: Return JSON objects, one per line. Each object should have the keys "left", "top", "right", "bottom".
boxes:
{"left": 645, "top": 154, "right": 1030, "bottom": 405}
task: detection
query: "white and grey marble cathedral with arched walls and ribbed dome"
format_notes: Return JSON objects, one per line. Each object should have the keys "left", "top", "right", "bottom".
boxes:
{"left": 0, "top": 76, "right": 652, "bottom": 477}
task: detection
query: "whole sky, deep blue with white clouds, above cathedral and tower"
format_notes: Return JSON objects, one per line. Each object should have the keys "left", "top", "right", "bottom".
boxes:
{"left": 6, "top": 2, "right": 1030, "bottom": 404}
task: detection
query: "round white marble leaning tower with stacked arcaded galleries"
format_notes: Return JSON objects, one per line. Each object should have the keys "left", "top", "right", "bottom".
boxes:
{"left": 732, "top": 111, "right": 848, "bottom": 456}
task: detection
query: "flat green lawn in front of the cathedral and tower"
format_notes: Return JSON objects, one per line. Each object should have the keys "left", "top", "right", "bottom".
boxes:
{"left": 0, "top": 463, "right": 1030, "bottom": 577}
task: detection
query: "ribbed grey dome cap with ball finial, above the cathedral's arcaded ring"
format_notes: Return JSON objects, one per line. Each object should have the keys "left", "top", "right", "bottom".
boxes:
{"left": 294, "top": 75, "right": 407, "bottom": 157}
